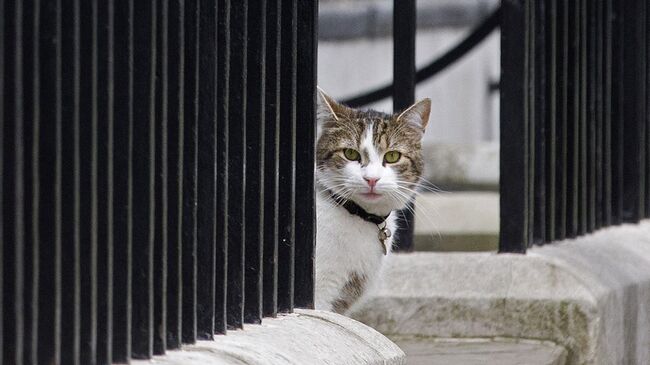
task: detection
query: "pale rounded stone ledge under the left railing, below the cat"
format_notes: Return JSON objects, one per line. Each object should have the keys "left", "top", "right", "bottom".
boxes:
{"left": 131, "top": 309, "right": 405, "bottom": 365}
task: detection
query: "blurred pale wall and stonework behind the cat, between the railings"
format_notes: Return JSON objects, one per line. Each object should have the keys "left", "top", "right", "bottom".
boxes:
{"left": 318, "top": 0, "right": 500, "bottom": 251}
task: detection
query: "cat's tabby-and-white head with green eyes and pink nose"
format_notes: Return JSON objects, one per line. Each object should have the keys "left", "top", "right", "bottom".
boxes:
{"left": 316, "top": 89, "right": 431, "bottom": 215}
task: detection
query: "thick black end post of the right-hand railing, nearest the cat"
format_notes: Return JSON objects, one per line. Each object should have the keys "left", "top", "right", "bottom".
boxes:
{"left": 499, "top": 2, "right": 529, "bottom": 252}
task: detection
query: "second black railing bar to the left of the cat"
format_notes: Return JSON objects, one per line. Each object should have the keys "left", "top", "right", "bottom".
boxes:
{"left": 277, "top": 0, "right": 297, "bottom": 312}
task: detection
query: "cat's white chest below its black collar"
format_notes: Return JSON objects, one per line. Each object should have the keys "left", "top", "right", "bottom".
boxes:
{"left": 315, "top": 194, "right": 395, "bottom": 310}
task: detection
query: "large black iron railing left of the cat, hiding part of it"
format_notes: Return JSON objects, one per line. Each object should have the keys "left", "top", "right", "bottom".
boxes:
{"left": 0, "top": 0, "right": 317, "bottom": 365}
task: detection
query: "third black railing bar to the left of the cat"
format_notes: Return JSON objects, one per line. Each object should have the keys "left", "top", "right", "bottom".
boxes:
{"left": 262, "top": 0, "right": 282, "bottom": 317}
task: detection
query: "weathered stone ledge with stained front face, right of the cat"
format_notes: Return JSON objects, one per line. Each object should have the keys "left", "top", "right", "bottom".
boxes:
{"left": 354, "top": 221, "right": 650, "bottom": 365}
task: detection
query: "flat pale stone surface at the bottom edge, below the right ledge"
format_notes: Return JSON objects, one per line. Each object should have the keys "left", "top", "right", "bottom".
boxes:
{"left": 392, "top": 338, "right": 566, "bottom": 365}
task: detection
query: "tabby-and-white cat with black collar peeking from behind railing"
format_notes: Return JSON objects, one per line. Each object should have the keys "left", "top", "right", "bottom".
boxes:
{"left": 315, "top": 88, "right": 431, "bottom": 314}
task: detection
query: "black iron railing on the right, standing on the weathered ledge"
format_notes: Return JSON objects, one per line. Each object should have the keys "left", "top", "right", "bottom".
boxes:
{"left": 499, "top": 0, "right": 650, "bottom": 252}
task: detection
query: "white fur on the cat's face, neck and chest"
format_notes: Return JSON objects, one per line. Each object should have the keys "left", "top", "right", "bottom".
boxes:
{"left": 315, "top": 123, "right": 402, "bottom": 310}
